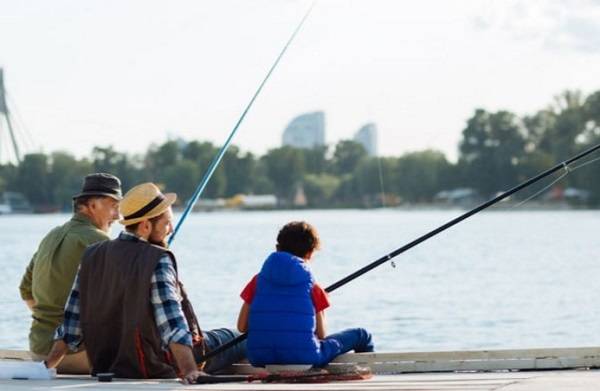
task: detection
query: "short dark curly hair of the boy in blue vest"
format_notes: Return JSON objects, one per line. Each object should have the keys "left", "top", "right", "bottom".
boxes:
{"left": 277, "top": 221, "right": 321, "bottom": 258}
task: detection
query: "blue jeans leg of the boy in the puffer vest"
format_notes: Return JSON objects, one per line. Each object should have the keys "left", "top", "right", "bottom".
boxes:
{"left": 315, "top": 328, "right": 375, "bottom": 367}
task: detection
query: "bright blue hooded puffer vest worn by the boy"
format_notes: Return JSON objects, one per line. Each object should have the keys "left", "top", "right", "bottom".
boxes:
{"left": 247, "top": 252, "right": 321, "bottom": 366}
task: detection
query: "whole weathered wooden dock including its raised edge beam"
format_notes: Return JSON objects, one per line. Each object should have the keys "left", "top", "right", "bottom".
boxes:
{"left": 0, "top": 347, "right": 600, "bottom": 391}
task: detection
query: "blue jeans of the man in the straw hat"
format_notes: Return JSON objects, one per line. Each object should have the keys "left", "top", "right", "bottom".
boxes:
{"left": 194, "top": 329, "right": 246, "bottom": 373}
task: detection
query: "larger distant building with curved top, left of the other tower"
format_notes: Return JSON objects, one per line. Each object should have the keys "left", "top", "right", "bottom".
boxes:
{"left": 282, "top": 111, "right": 325, "bottom": 148}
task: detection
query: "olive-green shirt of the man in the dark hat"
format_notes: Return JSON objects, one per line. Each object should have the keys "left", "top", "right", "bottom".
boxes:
{"left": 19, "top": 213, "right": 109, "bottom": 355}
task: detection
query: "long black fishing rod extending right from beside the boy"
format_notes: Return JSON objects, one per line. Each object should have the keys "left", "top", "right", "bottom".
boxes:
{"left": 200, "top": 144, "right": 600, "bottom": 363}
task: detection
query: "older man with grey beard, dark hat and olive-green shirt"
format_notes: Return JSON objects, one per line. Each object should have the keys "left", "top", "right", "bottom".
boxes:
{"left": 19, "top": 173, "right": 122, "bottom": 373}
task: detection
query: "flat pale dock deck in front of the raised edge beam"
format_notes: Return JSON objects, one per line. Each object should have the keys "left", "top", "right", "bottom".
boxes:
{"left": 0, "top": 370, "right": 600, "bottom": 391}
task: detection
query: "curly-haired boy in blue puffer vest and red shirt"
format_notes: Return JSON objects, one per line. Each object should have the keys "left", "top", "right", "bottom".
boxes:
{"left": 238, "top": 221, "right": 374, "bottom": 367}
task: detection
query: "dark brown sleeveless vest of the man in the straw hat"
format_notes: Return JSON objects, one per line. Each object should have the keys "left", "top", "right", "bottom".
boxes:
{"left": 79, "top": 239, "right": 203, "bottom": 379}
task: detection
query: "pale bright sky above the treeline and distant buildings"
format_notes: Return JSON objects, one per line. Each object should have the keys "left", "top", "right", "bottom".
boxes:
{"left": 0, "top": 0, "right": 600, "bottom": 162}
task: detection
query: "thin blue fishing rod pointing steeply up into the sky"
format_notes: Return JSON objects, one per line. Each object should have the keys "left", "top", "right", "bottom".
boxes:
{"left": 169, "top": 0, "right": 317, "bottom": 245}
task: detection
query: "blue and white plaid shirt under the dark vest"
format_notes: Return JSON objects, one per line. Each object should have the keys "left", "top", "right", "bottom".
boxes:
{"left": 54, "top": 232, "right": 192, "bottom": 350}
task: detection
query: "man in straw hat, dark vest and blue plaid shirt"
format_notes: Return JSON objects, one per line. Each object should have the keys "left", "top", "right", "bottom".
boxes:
{"left": 46, "top": 183, "right": 246, "bottom": 383}
